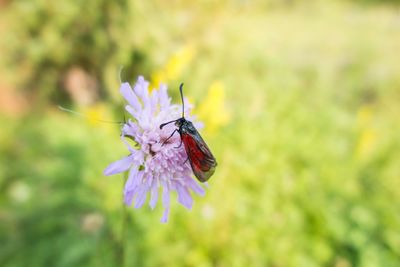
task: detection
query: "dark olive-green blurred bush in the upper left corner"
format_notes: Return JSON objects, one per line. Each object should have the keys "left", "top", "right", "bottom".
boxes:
{"left": 3, "top": 0, "right": 143, "bottom": 105}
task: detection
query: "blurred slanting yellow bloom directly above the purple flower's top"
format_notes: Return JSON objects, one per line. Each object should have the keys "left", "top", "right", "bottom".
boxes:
{"left": 150, "top": 45, "right": 195, "bottom": 90}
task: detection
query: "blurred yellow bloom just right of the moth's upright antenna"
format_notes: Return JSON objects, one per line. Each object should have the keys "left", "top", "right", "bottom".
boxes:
{"left": 197, "top": 81, "right": 231, "bottom": 133}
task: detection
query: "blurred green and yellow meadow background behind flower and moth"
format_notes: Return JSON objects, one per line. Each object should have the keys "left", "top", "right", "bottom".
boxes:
{"left": 0, "top": 0, "right": 400, "bottom": 267}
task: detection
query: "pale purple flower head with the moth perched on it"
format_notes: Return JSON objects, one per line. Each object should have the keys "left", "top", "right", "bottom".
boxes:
{"left": 104, "top": 76, "right": 204, "bottom": 222}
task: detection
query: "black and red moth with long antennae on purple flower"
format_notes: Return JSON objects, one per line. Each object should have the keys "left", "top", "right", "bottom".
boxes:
{"left": 160, "top": 83, "right": 217, "bottom": 183}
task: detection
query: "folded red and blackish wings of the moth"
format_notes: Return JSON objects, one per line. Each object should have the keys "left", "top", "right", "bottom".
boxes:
{"left": 181, "top": 134, "right": 217, "bottom": 182}
